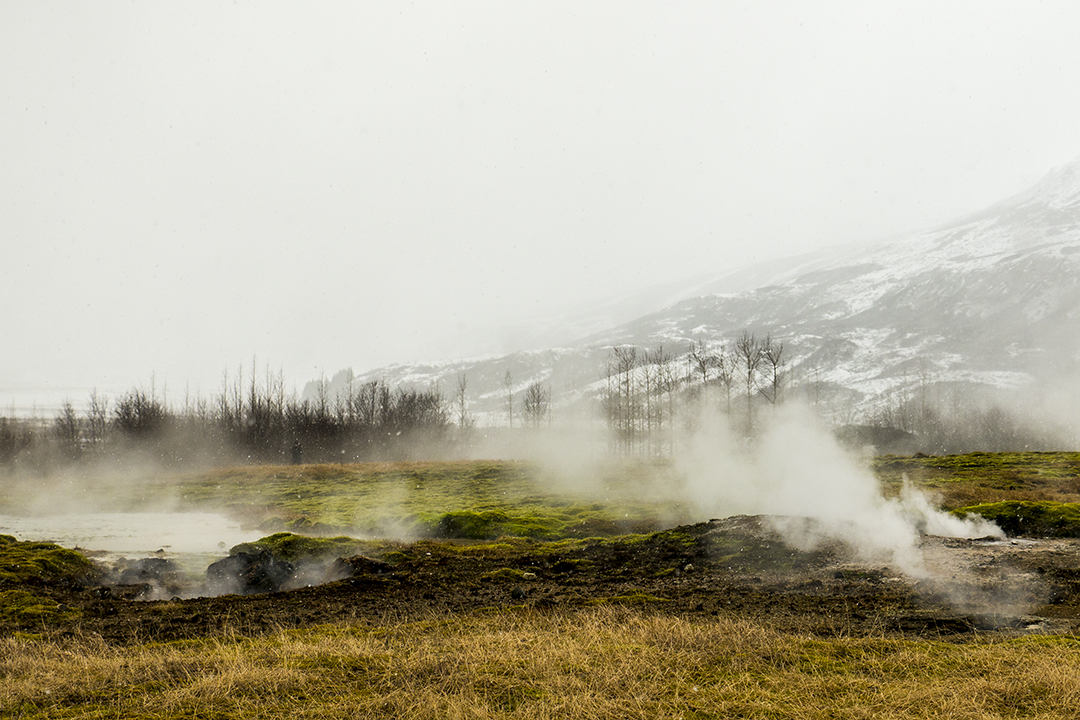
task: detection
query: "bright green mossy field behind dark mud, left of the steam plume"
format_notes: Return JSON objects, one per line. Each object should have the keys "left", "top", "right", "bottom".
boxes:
{"left": 173, "top": 461, "right": 682, "bottom": 540}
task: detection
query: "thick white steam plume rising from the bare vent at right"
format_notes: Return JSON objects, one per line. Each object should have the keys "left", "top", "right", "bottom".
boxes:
{"left": 676, "top": 404, "right": 1004, "bottom": 578}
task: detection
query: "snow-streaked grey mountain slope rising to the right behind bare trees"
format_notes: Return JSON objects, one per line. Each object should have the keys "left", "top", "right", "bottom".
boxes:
{"left": 306, "top": 161, "right": 1080, "bottom": 425}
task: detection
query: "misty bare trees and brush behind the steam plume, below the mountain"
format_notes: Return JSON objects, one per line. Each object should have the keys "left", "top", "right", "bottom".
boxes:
{"left": 599, "top": 330, "right": 1076, "bottom": 457}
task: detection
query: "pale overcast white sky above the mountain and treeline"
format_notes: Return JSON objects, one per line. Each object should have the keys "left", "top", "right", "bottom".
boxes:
{"left": 0, "top": 0, "right": 1080, "bottom": 416}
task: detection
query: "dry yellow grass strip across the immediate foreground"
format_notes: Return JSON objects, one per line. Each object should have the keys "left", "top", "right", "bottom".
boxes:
{"left": 0, "top": 607, "right": 1080, "bottom": 720}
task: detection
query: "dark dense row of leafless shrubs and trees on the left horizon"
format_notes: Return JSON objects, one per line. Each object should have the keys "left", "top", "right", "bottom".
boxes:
{"left": 0, "top": 368, "right": 454, "bottom": 466}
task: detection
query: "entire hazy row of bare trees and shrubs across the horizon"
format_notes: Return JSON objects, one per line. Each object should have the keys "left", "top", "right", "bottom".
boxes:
{"left": 0, "top": 330, "right": 1068, "bottom": 472}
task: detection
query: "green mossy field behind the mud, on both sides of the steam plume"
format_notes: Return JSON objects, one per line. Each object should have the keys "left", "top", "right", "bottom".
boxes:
{"left": 166, "top": 452, "right": 1080, "bottom": 540}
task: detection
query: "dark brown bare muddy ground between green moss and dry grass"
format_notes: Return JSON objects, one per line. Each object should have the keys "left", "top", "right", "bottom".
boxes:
{"left": 8, "top": 517, "right": 1080, "bottom": 643}
